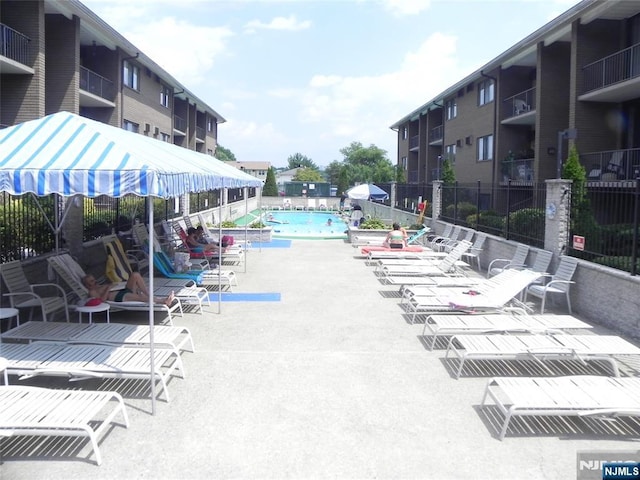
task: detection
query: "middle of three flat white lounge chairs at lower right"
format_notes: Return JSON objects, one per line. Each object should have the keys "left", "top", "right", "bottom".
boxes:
{"left": 445, "top": 334, "right": 640, "bottom": 378}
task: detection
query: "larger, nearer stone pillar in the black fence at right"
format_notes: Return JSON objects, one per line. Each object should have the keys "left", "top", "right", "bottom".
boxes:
{"left": 544, "top": 178, "right": 572, "bottom": 256}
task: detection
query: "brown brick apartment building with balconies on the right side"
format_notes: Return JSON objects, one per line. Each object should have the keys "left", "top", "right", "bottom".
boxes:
{"left": 391, "top": 0, "right": 640, "bottom": 187}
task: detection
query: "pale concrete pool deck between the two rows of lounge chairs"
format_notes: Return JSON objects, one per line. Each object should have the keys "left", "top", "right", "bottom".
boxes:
{"left": 0, "top": 241, "right": 636, "bottom": 480}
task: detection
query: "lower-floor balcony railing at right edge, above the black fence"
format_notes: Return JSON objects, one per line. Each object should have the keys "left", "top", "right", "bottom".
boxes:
{"left": 580, "top": 148, "right": 640, "bottom": 182}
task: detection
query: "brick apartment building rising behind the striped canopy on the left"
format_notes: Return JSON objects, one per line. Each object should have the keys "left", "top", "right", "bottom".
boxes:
{"left": 0, "top": 0, "right": 225, "bottom": 156}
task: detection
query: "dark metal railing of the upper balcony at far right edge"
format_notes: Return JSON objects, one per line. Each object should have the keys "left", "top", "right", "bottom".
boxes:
{"left": 582, "top": 43, "right": 640, "bottom": 93}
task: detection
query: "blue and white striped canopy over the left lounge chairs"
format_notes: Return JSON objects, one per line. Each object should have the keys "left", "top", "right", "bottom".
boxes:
{"left": 0, "top": 112, "right": 262, "bottom": 198}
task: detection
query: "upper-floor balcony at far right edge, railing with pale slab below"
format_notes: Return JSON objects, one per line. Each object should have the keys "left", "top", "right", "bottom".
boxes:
{"left": 578, "top": 43, "right": 640, "bottom": 102}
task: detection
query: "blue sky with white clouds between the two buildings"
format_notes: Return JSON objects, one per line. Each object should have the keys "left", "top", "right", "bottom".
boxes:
{"left": 83, "top": 0, "right": 579, "bottom": 167}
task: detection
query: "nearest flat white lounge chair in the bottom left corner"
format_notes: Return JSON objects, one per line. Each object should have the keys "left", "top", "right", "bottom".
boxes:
{"left": 0, "top": 385, "right": 129, "bottom": 465}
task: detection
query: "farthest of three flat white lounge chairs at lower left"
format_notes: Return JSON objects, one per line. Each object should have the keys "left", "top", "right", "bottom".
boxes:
{"left": 0, "top": 322, "right": 195, "bottom": 352}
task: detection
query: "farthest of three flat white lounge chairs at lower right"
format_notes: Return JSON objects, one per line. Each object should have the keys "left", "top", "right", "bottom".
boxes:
{"left": 422, "top": 314, "right": 592, "bottom": 350}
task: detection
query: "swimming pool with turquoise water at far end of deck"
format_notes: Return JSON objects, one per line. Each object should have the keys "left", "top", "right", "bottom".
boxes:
{"left": 262, "top": 210, "right": 347, "bottom": 240}
